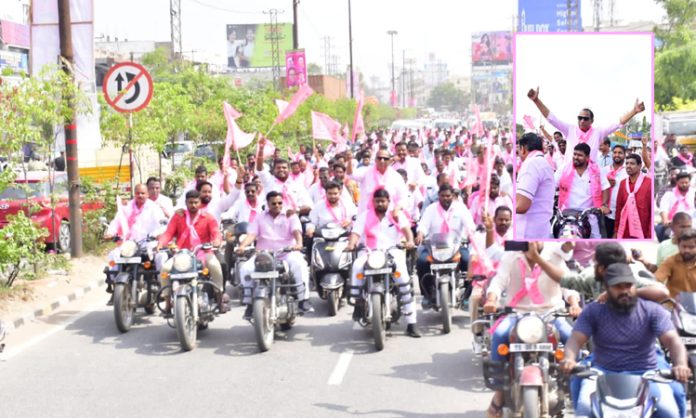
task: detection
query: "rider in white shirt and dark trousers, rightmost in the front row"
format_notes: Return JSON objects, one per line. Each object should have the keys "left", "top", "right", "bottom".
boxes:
{"left": 415, "top": 184, "right": 476, "bottom": 309}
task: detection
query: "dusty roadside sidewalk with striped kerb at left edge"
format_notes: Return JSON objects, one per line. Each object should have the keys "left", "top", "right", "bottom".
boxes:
{"left": 0, "top": 255, "right": 108, "bottom": 331}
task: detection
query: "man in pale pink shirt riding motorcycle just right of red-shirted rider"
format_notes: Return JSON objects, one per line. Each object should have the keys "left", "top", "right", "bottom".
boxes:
{"left": 237, "top": 191, "right": 314, "bottom": 320}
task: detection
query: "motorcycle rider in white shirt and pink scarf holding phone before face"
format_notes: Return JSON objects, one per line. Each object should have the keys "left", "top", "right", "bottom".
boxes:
{"left": 483, "top": 242, "right": 581, "bottom": 417}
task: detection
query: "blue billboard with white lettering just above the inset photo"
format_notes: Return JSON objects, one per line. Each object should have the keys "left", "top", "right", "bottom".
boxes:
{"left": 517, "top": 0, "right": 582, "bottom": 32}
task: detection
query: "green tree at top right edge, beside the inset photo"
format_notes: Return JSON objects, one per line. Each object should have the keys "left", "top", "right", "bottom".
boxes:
{"left": 655, "top": 0, "right": 696, "bottom": 110}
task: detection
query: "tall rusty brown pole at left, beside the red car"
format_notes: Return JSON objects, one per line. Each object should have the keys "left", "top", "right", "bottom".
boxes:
{"left": 58, "top": 0, "right": 82, "bottom": 257}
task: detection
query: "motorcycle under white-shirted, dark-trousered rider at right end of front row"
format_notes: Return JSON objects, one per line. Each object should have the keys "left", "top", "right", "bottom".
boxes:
{"left": 425, "top": 233, "right": 470, "bottom": 334}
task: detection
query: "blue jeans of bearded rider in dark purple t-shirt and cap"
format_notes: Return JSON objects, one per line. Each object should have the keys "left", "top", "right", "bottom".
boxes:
{"left": 570, "top": 347, "right": 686, "bottom": 418}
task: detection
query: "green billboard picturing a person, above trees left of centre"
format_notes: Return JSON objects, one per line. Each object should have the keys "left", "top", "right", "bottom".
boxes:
{"left": 227, "top": 23, "right": 292, "bottom": 68}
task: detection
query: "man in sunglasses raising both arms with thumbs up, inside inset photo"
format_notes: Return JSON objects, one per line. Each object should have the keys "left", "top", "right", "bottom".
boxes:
{"left": 527, "top": 87, "right": 645, "bottom": 164}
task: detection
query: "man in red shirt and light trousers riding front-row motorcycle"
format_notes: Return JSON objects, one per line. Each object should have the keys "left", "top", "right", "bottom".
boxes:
{"left": 157, "top": 190, "right": 224, "bottom": 312}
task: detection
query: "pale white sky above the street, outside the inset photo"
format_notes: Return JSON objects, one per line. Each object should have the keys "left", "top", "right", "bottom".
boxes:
{"left": 94, "top": 0, "right": 664, "bottom": 82}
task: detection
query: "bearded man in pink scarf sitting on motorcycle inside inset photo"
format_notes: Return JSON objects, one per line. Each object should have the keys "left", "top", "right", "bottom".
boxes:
{"left": 555, "top": 144, "right": 610, "bottom": 239}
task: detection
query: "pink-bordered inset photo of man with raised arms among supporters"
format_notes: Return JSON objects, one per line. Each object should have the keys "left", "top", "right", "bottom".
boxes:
{"left": 513, "top": 33, "right": 654, "bottom": 240}
